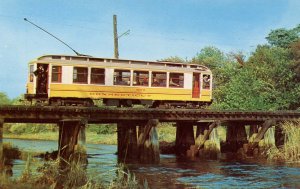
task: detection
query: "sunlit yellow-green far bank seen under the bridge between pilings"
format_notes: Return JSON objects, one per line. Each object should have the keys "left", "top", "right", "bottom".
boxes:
{"left": 3, "top": 123, "right": 176, "bottom": 145}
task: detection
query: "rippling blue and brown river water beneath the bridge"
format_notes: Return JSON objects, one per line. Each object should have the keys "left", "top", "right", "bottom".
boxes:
{"left": 4, "top": 139, "right": 300, "bottom": 189}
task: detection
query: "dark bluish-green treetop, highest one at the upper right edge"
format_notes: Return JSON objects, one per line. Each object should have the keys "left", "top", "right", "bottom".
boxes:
{"left": 266, "top": 24, "right": 300, "bottom": 48}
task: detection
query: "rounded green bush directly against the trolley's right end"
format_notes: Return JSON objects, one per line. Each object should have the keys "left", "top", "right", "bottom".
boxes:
{"left": 213, "top": 68, "right": 275, "bottom": 110}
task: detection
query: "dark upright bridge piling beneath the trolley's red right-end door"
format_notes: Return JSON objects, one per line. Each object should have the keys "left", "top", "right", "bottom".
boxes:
{"left": 175, "top": 122, "right": 195, "bottom": 156}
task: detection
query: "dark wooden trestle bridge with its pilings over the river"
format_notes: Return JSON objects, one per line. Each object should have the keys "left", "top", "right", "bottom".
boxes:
{"left": 0, "top": 106, "right": 300, "bottom": 162}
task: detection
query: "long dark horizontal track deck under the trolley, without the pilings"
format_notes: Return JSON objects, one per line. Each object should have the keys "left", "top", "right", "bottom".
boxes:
{"left": 0, "top": 106, "right": 300, "bottom": 123}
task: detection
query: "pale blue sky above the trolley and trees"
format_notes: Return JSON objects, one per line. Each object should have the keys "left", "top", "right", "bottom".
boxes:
{"left": 0, "top": 0, "right": 300, "bottom": 98}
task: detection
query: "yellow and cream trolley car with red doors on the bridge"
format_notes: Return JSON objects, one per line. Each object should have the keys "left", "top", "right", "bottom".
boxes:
{"left": 25, "top": 55, "right": 212, "bottom": 107}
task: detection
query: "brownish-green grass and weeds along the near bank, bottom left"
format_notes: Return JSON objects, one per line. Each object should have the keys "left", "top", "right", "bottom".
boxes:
{"left": 0, "top": 156, "right": 143, "bottom": 189}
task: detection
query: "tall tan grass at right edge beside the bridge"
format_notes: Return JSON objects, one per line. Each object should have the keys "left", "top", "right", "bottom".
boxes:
{"left": 267, "top": 121, "right": 300, "bottom": 163}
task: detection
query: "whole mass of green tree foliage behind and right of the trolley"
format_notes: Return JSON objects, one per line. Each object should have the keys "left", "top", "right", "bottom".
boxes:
{"left": 162, "top": 40, "right": 300, "bottom": 110}
